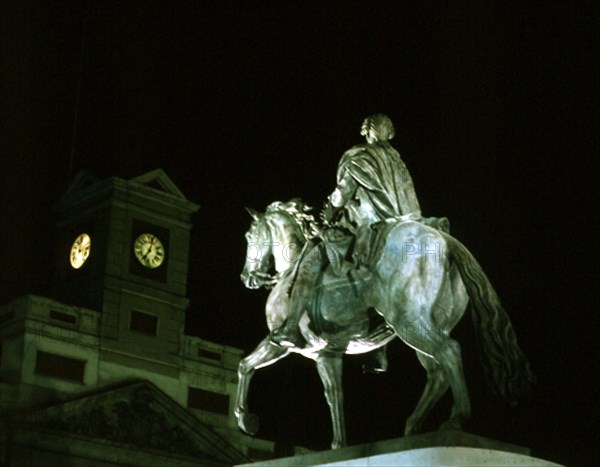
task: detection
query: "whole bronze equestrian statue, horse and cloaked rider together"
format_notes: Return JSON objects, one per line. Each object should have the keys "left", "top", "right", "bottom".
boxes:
{"left": 235, "top": 114, "right": 534, "bottom": 448}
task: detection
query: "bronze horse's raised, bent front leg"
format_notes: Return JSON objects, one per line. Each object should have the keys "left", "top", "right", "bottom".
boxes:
{"left": 234, "top": 337, "right": 289, "bottom": 435}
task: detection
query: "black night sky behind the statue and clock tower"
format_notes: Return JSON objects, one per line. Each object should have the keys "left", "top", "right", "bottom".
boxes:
{"left": 0, "top": 1, "right": 598, "bottom": 465}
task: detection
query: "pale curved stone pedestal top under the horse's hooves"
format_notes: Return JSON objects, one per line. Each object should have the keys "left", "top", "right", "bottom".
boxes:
{"left": 240, "top": 431, "right": 561, "bottom": 467}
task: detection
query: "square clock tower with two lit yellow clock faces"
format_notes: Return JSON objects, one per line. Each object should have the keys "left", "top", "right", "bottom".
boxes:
{"left": 53, "top": 169, "right": 198, "bottom": 364}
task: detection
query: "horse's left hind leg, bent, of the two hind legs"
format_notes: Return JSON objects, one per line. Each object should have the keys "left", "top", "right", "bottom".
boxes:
{"left": 404, "top": 352, "right": 449, "bottom": 436}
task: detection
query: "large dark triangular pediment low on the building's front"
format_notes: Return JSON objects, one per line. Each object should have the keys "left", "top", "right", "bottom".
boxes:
{"left": 18, "top": 381, "right": 248, "bottom": 465}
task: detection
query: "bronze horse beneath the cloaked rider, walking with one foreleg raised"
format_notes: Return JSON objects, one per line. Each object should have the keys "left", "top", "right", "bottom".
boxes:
{"left": 235, "top": 200, "right": 533, "bottom": 448}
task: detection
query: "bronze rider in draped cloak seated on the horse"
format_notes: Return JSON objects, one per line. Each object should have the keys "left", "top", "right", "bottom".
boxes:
{"left": 272, "top": 114, "right": 436, "bottom": 371}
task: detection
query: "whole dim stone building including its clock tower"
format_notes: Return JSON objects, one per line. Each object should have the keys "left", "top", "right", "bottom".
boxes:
{"left": 0, "top": 169, "right": 274, "bottom": 465}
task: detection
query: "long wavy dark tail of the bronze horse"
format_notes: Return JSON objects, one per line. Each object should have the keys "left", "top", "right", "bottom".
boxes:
{"left": 444, "top": 235, "right": 535, "bottom": 404}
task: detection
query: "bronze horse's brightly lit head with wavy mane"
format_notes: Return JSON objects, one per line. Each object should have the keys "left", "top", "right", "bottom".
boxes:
{"left": 241, "top": 199, "right": 315, "bottom": 289}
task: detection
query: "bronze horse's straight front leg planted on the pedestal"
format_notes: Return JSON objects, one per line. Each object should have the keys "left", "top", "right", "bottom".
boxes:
{"left": 317, "top": 354, "right": 346, "bottom": 449}
